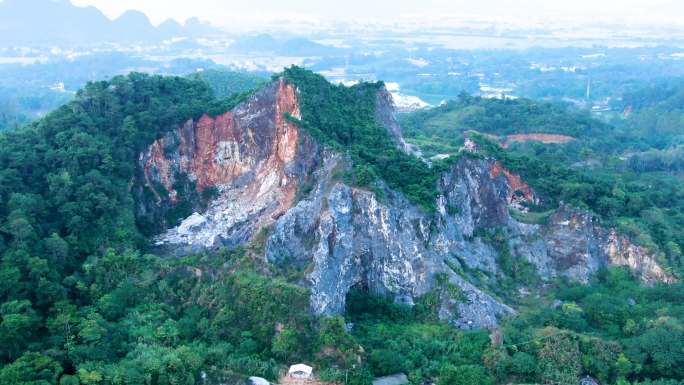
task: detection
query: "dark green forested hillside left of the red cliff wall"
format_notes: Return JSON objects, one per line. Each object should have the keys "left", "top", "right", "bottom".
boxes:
{"left": 0, "top": 74, "right": 214, "bottom": 264}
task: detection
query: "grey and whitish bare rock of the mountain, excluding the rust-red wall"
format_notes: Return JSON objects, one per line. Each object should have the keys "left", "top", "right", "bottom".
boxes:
{"left": 141, "top": 84, "right": 674, "bottom": 329}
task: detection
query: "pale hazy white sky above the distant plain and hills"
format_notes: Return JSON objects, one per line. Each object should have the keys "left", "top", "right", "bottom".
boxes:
{"left": 72, "top": 0, "right": 684, "bottom": 27}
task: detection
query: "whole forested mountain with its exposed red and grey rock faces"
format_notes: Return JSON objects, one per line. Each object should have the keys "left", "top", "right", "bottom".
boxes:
{"left": 0, "top": 68, "right": 684, "bottom": 385}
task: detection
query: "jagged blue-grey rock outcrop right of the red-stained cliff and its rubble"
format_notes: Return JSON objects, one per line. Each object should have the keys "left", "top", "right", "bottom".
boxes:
{"left": 266, "top": 150, "right": 671, "bottom": 329}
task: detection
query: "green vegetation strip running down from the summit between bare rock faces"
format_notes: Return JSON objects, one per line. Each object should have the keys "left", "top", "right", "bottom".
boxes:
{"left": 283, "top": 66, "right": 443, "bottom": 210}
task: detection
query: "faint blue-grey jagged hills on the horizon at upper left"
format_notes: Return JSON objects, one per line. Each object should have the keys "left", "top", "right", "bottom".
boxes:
{"left": 0, "top": 0, "right": 216, "bottom": 46}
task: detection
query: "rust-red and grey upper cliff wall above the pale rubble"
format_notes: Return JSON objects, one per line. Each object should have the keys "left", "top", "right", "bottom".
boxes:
{"left": 145, "top": 80, "right": 299, "bottom": 192}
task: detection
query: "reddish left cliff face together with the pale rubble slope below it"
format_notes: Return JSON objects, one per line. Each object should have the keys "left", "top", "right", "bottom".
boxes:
{"left": 141, "top": 79, "right": 313, "bottom": 246}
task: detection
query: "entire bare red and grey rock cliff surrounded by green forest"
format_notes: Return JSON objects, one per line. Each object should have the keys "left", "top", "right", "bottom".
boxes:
{"left": 137, "top": 70, "right": 675, "bottom": 329}
